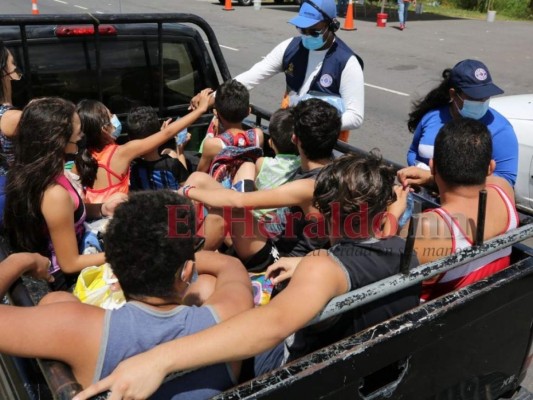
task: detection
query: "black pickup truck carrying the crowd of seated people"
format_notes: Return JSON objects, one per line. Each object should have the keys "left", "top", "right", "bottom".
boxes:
{"left": 0, "top": 14, "right": 533, "bottom": 400}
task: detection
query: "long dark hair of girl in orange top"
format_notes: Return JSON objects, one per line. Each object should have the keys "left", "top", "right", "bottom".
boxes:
{"left": 75, "top": 100, "right": 113, "bottom": 188}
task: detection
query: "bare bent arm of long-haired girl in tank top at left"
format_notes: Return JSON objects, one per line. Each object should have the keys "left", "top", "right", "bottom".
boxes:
{"left": 41, "top": 185, "right": 105, "bottom": 273}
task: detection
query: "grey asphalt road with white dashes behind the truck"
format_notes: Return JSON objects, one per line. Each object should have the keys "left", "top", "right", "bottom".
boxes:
{"left": 0, "top": 0, "right": 533, "bottom": 163}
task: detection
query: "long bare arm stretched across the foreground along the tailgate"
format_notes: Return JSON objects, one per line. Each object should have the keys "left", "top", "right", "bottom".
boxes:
{"left": 73, "top": 256, "right": 349, "bottom": 400}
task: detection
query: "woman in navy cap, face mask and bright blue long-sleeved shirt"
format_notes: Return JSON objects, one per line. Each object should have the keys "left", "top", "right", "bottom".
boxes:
{"left": 407, "top": 59, "right": 518, "bottom": 186}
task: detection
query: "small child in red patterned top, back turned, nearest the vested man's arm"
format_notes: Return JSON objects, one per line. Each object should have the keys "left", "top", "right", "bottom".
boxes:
{"left": 197, "top": 80, "right": 263, "bottom": 182}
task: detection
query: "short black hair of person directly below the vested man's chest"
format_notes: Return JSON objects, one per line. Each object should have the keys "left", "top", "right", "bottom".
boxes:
{"left": 291, "top": 99, "right": 341, "bottom": 161}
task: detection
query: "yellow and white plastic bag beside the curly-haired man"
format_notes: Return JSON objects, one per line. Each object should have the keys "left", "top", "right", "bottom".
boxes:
{"left": 73, "top": 263, "right": 126, "bottom": 310}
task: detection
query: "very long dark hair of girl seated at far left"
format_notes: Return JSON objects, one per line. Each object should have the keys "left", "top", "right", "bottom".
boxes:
{"left": 4, "top": 97, "right": 76, "bottom": 254}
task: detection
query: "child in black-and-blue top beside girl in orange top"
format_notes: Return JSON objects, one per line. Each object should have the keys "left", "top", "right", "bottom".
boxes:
{"left": 128, "top": 107, "right": 189, "bottom": 190}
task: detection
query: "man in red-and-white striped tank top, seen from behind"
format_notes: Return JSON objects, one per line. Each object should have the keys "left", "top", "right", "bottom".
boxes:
{"left": 398, "top": 118, "right": 518, "bottom": 300}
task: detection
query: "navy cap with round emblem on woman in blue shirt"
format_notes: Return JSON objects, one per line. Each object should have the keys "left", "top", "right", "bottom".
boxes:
{"left": 450, "top": 60, "right": 503, "bottom": 99}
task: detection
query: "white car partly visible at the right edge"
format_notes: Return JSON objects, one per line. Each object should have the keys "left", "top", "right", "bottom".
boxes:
{"left": 490, "top": 94, "right": 533, "bottom": 208}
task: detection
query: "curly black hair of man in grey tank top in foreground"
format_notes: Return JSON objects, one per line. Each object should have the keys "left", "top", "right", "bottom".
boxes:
{"left": 104, "top": 189, "right": 195, "bottom": 298}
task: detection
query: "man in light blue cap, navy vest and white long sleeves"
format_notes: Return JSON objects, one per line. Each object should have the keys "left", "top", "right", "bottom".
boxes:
{"left": 191, "top": 0, "right": 365, "bottom": 141}
